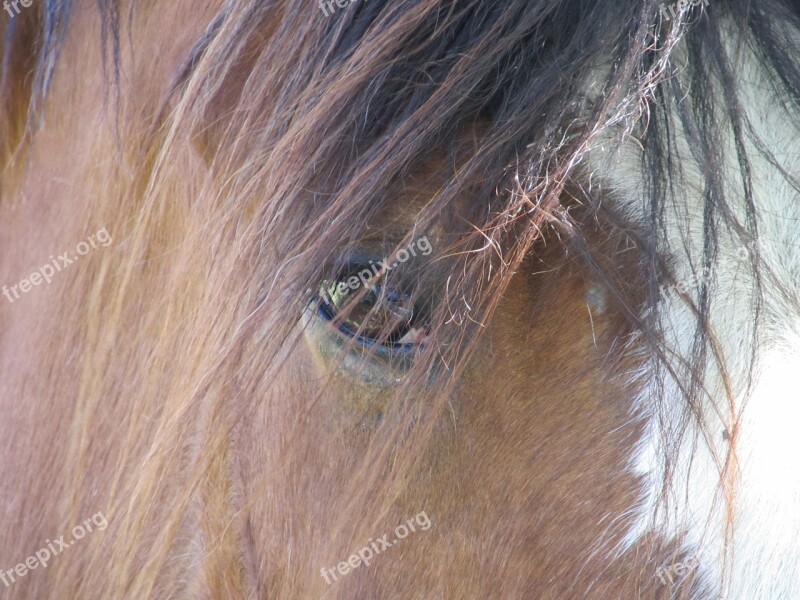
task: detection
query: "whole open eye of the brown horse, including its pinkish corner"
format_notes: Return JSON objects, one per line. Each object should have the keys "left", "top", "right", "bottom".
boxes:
{"left": 318, "top": 278, "right": 427, "bottom": 349}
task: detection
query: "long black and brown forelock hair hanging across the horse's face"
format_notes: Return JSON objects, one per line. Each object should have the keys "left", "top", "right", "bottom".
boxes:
{"left": 0, "top": 0, "right": 800, "bottom": 598}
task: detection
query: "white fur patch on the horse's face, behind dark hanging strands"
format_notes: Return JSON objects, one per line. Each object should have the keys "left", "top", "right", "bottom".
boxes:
{"left": 590, "top": 23, "right": 800, "bottom": 600}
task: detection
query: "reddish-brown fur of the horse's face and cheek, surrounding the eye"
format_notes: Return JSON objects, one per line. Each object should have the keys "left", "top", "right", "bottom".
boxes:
{"left": 0, "top": 1, "right": 716, "bottom": 599}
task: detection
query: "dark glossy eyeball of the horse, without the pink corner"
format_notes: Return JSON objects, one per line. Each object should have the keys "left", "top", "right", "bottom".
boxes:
{"left": 327, "top": 282, "right": 414, "bottom": 342}
